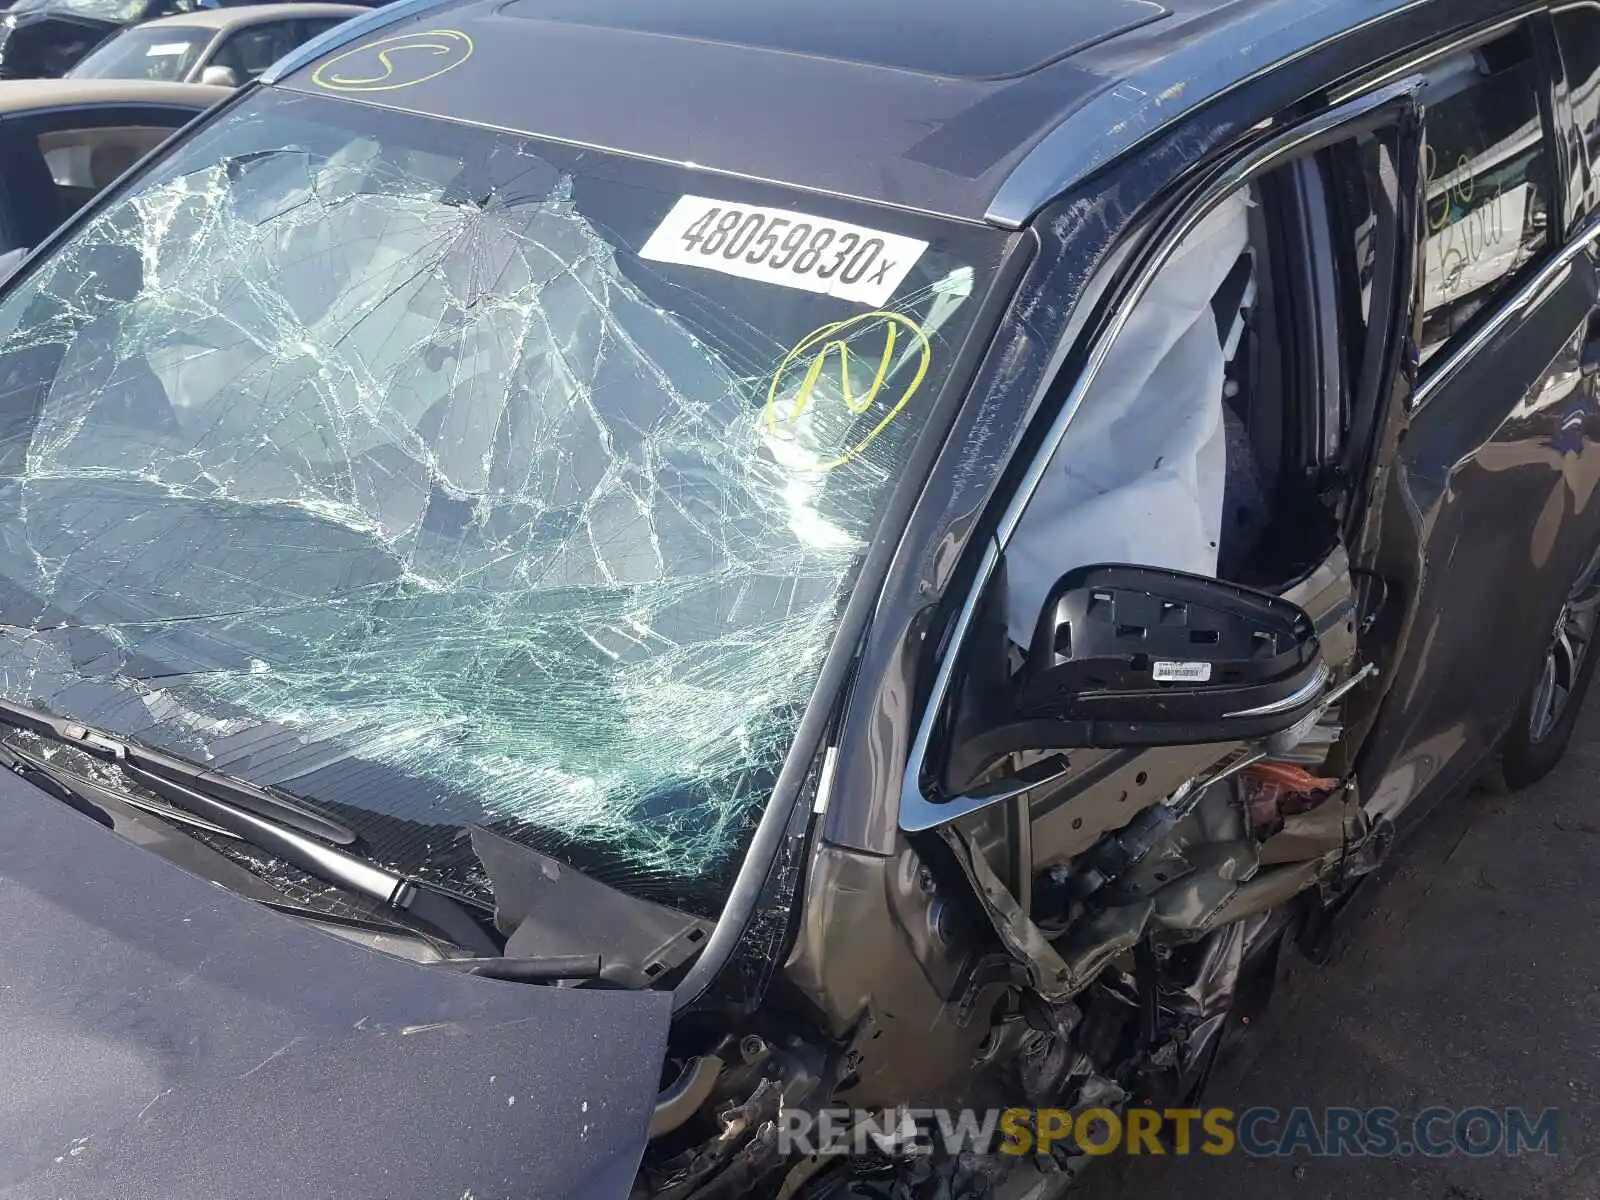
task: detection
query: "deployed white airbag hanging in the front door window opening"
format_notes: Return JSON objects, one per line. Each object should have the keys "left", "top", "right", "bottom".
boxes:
{"left": 1005, "top": 190, "right": 1250, "bottom": 646}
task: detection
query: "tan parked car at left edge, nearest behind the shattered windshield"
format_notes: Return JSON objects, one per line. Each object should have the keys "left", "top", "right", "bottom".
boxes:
{"left": 0, "top": 78, "right": 232, "bottom": 254}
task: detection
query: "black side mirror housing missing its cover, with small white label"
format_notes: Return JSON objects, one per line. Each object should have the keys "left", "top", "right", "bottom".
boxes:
{"left": 1016, "top": 566, "right": 1328, "bottom": 749}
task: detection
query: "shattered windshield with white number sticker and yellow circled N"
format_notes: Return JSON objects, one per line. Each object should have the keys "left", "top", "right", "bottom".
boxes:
{"left": 0, "top": 90, "right": 1005, "bottom": 907}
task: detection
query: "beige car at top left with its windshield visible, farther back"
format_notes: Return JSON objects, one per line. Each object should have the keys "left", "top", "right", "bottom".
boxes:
{"left": 67, "top": 3, "right": 370, "bottom": 88}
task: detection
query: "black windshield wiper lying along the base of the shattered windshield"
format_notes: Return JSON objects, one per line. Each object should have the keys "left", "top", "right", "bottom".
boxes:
{"left": 0, "top": 701, "right": 501, "bottom": 957}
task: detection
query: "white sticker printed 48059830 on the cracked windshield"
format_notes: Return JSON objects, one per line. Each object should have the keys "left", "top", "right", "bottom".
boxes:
{"left": 638, "top": 195, "right": 928, "bottom": 306}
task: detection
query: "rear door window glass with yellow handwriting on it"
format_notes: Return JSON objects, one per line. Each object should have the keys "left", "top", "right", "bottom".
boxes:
{"left": 1419, "top": 29, "right": 1552, "bottom": 362}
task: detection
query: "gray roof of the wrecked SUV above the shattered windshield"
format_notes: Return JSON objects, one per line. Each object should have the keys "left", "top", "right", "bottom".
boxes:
{"left": 264, "top": 0, "right": 1517, "bottom": 227}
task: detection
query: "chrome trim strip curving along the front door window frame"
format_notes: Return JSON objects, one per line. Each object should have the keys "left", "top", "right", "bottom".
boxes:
{"left": 899, "top": 77, "right": 1426, "bottom": 834}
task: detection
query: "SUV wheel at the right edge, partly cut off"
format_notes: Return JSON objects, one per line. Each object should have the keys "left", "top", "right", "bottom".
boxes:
{"left": 1499, "top": 554, "right": 1600, "bottom": 792}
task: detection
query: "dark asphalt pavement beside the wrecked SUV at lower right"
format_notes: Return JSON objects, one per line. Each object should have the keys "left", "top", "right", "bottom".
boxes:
{"left": 1083, "top": 693, "right": 1600, "bottom": 1200}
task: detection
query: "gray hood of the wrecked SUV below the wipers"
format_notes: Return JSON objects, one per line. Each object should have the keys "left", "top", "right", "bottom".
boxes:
{"left": 0, "top": 773, "right": 670, "bottom": 1200}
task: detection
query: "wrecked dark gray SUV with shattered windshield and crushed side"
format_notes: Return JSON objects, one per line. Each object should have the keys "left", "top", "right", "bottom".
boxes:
{"left": 0, "top": 0, "right": 1600, "bottom": 1200}
